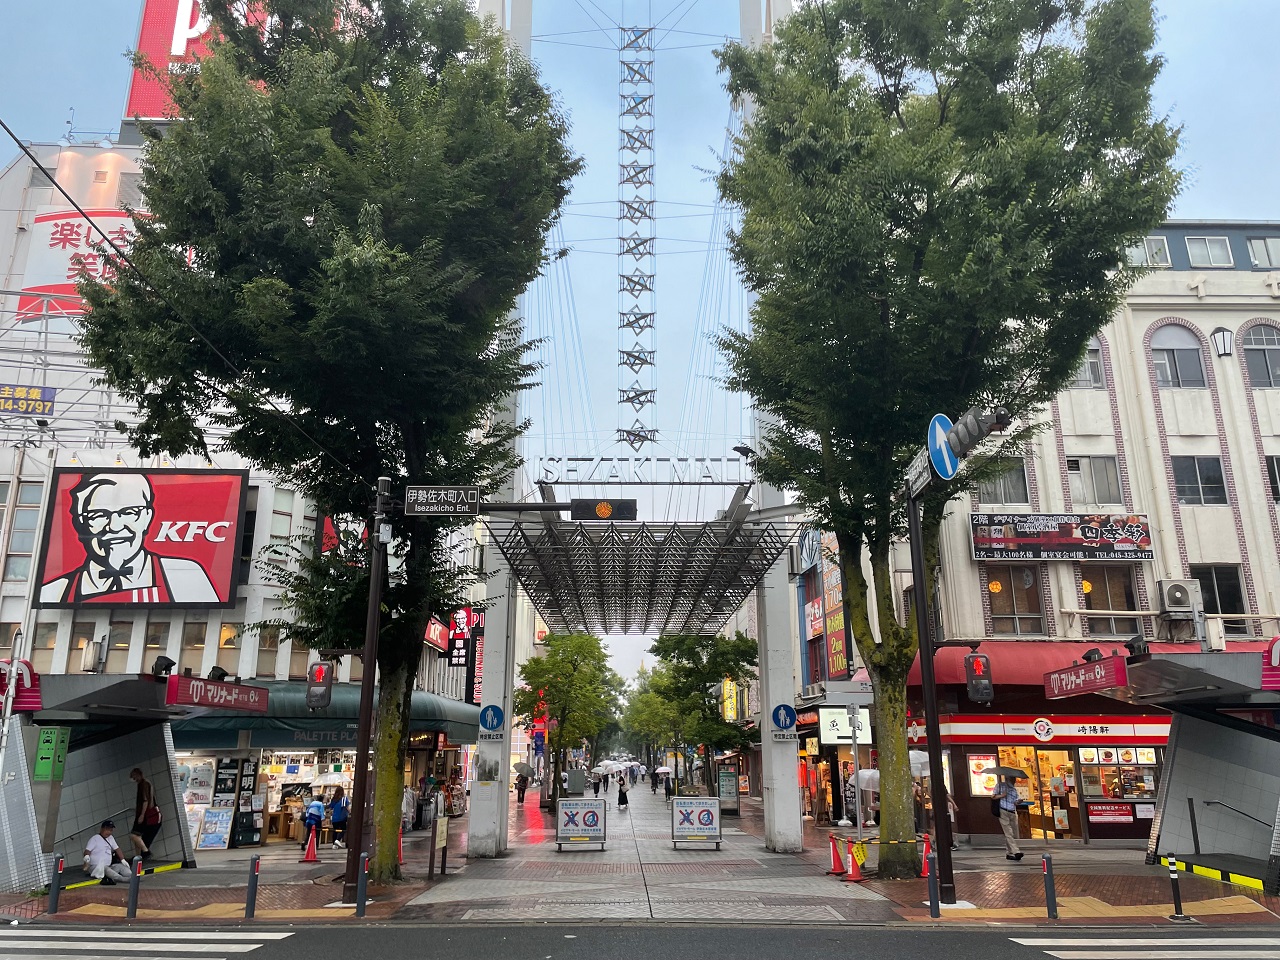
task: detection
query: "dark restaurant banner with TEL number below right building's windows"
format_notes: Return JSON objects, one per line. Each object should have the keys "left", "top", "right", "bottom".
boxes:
{"left": 969, "top": 513, "right": 1156, "bottom": 562}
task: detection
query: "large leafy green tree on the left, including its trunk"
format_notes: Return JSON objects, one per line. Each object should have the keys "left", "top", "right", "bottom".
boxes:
{"left": 82, "top": 0, "right": 580, "bottom": 882}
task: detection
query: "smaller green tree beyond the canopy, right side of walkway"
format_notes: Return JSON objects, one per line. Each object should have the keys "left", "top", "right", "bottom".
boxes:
{"left": 649, "top": 631, "right": 759, "bottom": 790}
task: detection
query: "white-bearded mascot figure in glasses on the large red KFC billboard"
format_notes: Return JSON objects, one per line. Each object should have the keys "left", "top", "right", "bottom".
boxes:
{"left": 40, "top": 474, "right": 219, "bottom": 604}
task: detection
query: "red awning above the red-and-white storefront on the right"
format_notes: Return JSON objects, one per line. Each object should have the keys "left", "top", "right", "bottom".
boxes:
{"left": 906, "top": 640, "right": 1271, "bottom": 687}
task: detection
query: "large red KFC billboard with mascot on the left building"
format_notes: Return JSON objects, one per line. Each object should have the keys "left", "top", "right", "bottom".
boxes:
{"left": 36, "top": 467, "right": 248, "bottom": 608}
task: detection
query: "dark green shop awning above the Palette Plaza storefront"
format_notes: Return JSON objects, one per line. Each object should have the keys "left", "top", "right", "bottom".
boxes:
{"left": 173, "top": 681, "right": 480, "bottom": 749}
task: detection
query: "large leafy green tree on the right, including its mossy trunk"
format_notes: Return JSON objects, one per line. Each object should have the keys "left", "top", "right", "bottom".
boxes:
{"left": 718, "top": 0, "right": 1179, "bottom": 877}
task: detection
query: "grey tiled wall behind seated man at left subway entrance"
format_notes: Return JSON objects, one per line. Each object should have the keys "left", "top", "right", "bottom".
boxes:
{"left": 54, "top": 723, "right": 183, "bottom": 869}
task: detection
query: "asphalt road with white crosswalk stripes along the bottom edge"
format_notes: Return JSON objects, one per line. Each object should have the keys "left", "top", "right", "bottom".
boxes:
{"left": 0, "top": 923, "right": 1280, "bottom": 960}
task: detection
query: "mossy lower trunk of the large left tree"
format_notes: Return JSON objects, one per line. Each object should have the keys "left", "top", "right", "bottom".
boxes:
{"left": 368, "top": 664, "right": 413, "bottom": 883}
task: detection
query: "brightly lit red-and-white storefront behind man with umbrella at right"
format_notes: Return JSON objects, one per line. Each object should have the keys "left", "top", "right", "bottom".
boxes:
{"left": 908, "top": 713, "right": 1170, "bottom": 842}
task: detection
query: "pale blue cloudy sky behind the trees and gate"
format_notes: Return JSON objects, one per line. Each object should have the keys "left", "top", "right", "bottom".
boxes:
{"left": 0, "top": 0, "right": 1280, "bottom": 676}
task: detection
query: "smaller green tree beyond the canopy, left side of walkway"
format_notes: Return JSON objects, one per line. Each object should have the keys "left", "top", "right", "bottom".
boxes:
{"left": 513, "top": 634, "right": 617, "bottom": 803}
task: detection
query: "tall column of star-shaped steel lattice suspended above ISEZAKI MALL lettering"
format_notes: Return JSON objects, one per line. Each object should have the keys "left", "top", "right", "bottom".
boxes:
{"left": 618, "top": 27, "right": 658, "bottom": 451}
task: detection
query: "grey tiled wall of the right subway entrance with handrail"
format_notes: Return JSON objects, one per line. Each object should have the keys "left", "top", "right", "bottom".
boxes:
{"left": 1158, "top": 717, "right": 1280, "bottom": 860}
